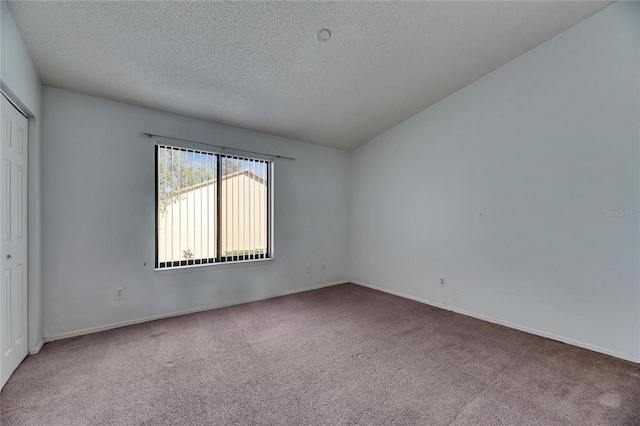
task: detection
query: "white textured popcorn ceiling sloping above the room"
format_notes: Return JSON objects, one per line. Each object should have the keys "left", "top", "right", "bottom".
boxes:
{"left": 9, "top": 1, "right": 609, "bottom": 149}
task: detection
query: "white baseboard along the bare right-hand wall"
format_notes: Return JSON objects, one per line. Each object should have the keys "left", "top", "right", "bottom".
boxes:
{"left": 350, "top": 280, "right": 640, "bottom": 364}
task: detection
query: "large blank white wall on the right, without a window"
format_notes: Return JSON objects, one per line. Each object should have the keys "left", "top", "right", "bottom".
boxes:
{"left": 349, "top": 2, "right": 640, "bottom": 362}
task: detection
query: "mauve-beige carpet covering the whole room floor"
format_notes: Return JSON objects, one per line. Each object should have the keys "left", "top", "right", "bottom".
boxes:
{"left": 0, "top": 284, "right": 640, "bottom": 426}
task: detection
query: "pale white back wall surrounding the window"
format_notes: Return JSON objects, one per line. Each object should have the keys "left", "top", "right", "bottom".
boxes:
{"left": 43, "top": 87, "right": 350, "bottom": 338}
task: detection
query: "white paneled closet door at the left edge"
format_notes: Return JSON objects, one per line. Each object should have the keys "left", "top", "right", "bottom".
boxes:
{"left": 0, "top": 95, "right": 28, "bottom": 389}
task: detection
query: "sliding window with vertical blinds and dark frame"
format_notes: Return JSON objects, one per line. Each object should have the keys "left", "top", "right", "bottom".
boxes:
{"left": 156, "top": 144, "right": 273, "bottom": 269}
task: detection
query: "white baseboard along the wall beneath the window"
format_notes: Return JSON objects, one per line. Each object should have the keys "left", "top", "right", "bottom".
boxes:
{"left": 45, "top": 281, "right": 349, "bottom": 342}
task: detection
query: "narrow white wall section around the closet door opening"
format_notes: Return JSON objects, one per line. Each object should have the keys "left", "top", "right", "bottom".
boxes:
{"left": 0, "top": 0, "right": 43, "bottom": 351}
